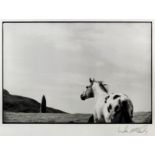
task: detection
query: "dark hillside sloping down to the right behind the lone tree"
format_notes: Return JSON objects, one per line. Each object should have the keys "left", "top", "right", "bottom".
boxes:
{"left": 3, "top": 89, "right": 65, "bottom": 113}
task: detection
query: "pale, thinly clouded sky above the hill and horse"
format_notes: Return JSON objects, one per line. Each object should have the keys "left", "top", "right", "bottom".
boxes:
{"left": 3, "top": 23, "right": 151, "bottom": 113}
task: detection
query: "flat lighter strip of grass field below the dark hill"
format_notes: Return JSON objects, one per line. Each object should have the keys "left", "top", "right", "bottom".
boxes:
{"left": 3, "top": 112, "right": 151, "bottom": 124}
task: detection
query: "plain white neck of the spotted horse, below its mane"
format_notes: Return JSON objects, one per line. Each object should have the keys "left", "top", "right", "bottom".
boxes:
{"left": 93, "top": 85, "right": 107, "bottom": 103}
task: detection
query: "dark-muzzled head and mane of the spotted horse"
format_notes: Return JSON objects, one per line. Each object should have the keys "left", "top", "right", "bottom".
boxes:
{"left": 81, "top": 78, "right": 108, "bottom": 100}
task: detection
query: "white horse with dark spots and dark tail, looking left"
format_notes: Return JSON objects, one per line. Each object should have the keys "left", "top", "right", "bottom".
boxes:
{"left": 81, "top": 78, "right": 133, "bottom": 123}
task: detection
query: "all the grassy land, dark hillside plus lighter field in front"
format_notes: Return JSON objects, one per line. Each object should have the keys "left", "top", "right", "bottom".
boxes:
{"left": 3, "top": 90, "right": 152, "bottom": 124}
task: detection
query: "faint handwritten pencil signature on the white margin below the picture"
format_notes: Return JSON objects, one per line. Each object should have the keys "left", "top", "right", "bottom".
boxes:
{"left": 118, "top": 124, "right": 148, "bottom": 134}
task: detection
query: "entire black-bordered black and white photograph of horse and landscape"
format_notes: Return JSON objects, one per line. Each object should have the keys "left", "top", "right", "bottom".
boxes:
{"left": 2, "top": 21, "right": 152, "bottom": 125}
